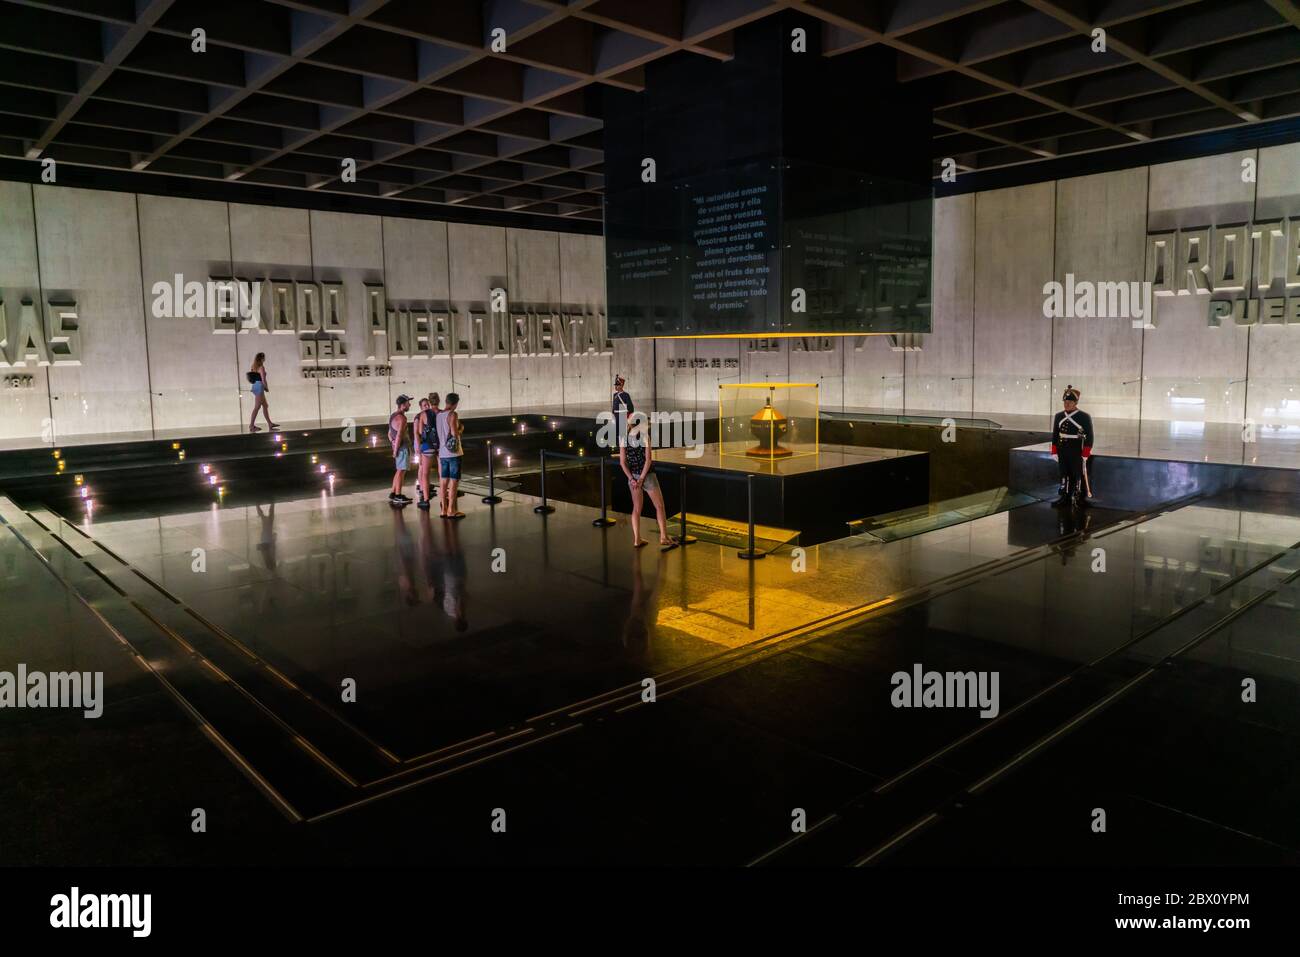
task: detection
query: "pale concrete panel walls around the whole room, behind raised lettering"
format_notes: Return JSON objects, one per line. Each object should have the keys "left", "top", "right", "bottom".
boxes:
{"left": 0, "top": 143, "right": 1300, "bottom": 445}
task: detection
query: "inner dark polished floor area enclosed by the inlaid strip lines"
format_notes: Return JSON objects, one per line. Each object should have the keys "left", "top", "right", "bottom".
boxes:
{"left": 61, "top": 478, "right": 1097, "bottom": 759}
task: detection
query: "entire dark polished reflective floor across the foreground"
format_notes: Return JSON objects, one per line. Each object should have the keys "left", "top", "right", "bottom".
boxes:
{"left": 0, "top": 470, "right": 1300, "bottom": 865}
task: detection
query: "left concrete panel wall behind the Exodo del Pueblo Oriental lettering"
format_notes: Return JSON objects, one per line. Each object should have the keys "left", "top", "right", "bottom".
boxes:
{"left": 0, "top": 182, "right": 608, "bottom": 447}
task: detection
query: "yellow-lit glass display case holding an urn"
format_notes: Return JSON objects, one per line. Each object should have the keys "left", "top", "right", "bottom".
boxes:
{"left": 718, "top": 382, "right": 820, "bottom": 462}
